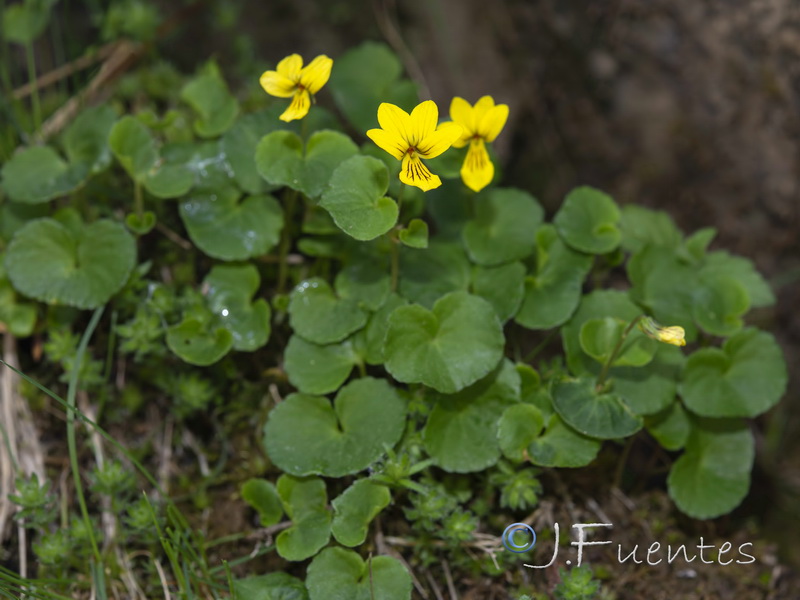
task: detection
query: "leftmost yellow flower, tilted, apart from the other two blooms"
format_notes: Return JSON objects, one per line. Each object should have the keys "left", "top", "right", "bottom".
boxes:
{"left": 259, "top": 54, "right": 333, "bottom": 122}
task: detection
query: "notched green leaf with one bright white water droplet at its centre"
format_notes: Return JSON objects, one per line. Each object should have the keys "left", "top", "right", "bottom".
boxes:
{"left": 203, "top": 265, "right": 272, "bottom": 352}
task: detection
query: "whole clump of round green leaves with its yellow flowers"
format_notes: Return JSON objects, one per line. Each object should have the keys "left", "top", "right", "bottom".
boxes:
{"left": 0, "top": 4, "right": 787, "bottom": 600}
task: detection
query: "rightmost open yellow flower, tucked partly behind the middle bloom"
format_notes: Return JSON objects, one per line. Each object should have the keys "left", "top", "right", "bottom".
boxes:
{"left": 450, "top": 96, "right": 508, "bottom": 192}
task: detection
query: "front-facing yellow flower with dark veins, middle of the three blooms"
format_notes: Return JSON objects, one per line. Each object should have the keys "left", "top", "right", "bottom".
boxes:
{"left": 367, "top": 100, "right": 461, "bottom": 192}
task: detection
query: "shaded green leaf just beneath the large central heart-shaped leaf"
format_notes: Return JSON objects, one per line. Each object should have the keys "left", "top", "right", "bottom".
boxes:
{"left": 422, "top": 361, "right": 520, "bottom": 473}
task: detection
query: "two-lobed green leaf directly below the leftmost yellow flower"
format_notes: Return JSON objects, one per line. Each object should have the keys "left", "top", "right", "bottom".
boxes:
{"left": 256, "top": 131, "right": 358, "bottom": 198}
